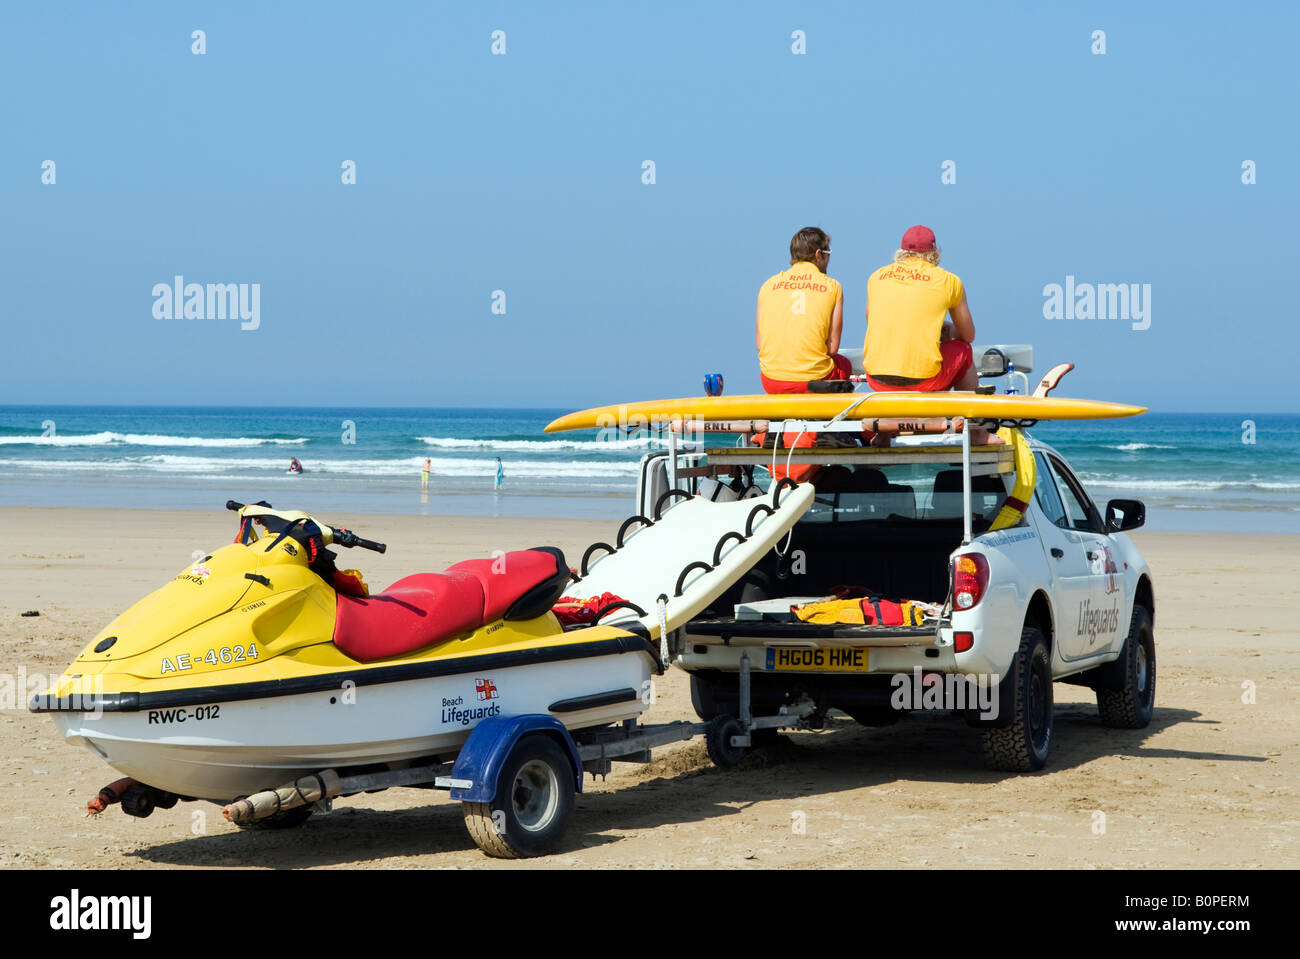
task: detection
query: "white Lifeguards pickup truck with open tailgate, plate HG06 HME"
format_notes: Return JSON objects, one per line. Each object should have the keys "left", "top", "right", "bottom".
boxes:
{"left": 638, "top": 343, "right": 1156, "bottom": 772}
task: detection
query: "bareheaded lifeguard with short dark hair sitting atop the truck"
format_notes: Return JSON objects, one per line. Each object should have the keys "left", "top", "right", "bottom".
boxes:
{"left": 754, "top": 226, "right": 852, "bottom": 392}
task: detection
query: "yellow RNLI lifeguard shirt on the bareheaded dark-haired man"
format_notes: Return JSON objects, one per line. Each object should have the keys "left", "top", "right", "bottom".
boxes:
{"left": 758, "top": 261, "right": 844, "bottom": 383}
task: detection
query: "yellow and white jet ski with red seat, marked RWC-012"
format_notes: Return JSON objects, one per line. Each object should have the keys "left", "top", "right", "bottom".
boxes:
{"left": 30, "top": 502, "right": 663, "bottom": 815}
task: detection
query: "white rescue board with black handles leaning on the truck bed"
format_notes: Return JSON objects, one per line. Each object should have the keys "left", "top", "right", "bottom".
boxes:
{"left": 564, "top": 483, "right": 815, "bottom": 637}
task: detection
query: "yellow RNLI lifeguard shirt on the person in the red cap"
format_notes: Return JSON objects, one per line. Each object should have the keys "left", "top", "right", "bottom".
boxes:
{"left": 862, "top": 257, "right": 965, "bottom": 379}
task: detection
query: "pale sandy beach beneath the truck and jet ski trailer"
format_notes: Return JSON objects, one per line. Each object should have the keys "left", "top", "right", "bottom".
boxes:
{"left": 0, "top": 508, "right": 1300, "bottom": 869}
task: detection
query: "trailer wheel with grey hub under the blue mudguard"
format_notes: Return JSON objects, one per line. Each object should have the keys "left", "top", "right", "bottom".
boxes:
{"left": 460, "top": 735, "right": 573, "bottom": 859}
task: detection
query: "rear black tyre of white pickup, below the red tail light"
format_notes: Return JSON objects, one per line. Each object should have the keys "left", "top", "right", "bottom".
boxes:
{"left": 982, "top": 626, "right": 1052, "bottom": 772}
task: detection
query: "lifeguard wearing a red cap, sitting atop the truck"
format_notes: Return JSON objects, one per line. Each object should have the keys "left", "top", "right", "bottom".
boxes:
{"left": 862, "top": 226, "right": 989, "bottom": 443}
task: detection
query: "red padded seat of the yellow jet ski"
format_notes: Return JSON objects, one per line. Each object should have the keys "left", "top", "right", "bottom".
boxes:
{"left": 334, "top": 546, "right": 569, "bottom": 663}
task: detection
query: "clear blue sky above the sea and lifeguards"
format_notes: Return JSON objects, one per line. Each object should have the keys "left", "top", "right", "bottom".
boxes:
{"left": 0, "top": 0, "right": 1300, "bottom": 413}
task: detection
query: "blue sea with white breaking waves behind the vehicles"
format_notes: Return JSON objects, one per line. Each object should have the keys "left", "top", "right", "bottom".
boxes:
{"left": 0, "top": 405, "right": 1300, "bottom": 533}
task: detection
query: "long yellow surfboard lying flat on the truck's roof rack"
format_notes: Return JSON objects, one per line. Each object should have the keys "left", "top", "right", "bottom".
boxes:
{"left": 546, "top": 392, "right": 1147, "bottom": 433}
